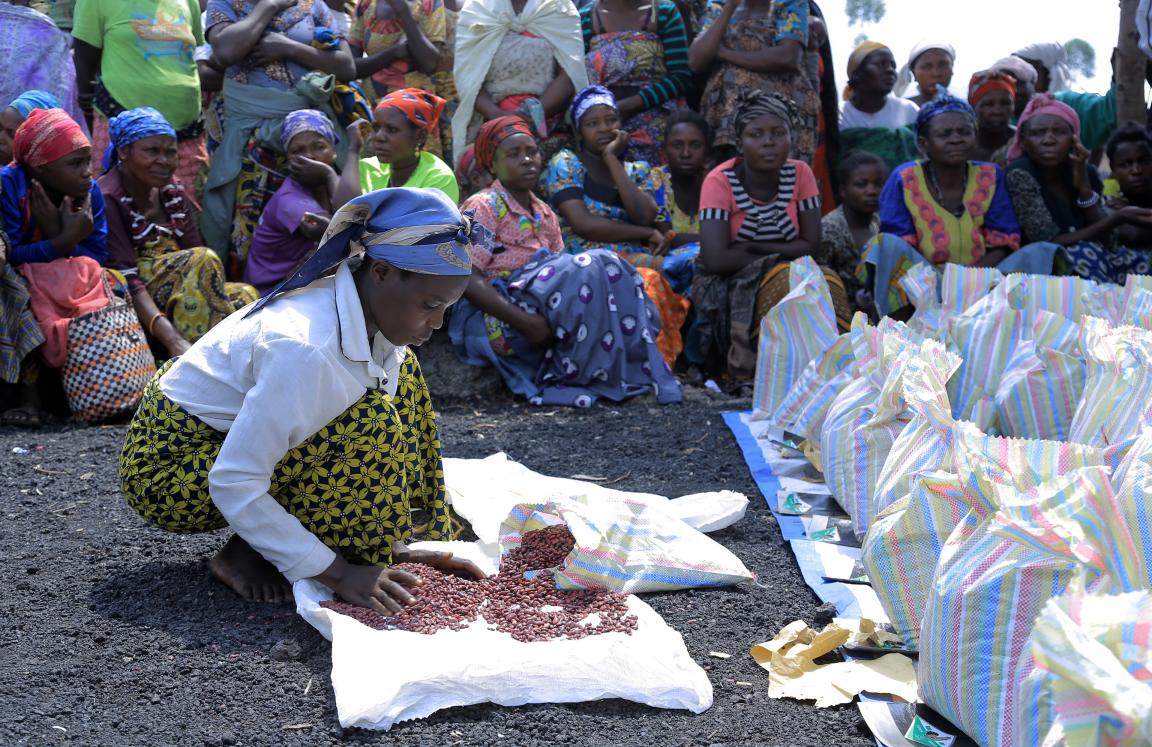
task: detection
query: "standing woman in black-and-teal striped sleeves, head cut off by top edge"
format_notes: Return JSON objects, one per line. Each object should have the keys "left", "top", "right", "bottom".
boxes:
{"left": 579, "top": 0, "right": 692, "bottom": 166}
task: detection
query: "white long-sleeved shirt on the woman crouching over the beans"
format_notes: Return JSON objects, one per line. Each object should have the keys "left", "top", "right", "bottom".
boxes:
{"left": 160, "top": 264, "right": 408, "bottom": 581}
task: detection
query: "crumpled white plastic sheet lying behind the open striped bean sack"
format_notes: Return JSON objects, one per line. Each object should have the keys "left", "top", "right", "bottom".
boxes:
{"left": 444, "top": 452, "right": 748, "bottom": 544}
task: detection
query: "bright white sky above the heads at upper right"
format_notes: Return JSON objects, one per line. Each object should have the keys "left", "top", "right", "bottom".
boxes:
{"left": 817, "top": 0, "right": 1120, "bottom": 96}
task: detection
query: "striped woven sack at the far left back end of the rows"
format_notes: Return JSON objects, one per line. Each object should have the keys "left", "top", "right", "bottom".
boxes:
{"left": 752, "top": 257, "right": 839, "bottom": 418}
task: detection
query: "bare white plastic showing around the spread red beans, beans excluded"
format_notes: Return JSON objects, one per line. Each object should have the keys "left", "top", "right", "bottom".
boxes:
{"left": 293, "top": 542, "right": 712, "bottom": 730}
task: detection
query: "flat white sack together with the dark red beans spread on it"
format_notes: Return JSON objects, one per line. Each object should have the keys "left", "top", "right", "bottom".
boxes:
{"left": 294, "top": 537, "right": 712, "bottom": 730}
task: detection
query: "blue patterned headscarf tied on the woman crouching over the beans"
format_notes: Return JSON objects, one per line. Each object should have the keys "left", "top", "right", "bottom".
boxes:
{"left": 248, "top": 187, "right": 492, "bottom": 314}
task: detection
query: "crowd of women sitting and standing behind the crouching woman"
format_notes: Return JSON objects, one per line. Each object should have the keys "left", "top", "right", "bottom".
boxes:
{"left": 0, "top": 0, "right": 1152, "bottom": 427}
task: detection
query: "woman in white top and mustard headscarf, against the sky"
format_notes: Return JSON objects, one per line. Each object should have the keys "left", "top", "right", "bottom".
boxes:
{"left": 840, "top": 42, "right": 919, "bottom": 168}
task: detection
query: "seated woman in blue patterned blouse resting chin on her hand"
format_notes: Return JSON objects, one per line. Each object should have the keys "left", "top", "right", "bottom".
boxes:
{"left": 544, "top": 85, "right": 688, "bottom": 365}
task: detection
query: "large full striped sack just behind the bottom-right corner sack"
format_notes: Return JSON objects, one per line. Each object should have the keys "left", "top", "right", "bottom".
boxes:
{"left": 917, "top": 467, "right": 1128, "bottom": 747}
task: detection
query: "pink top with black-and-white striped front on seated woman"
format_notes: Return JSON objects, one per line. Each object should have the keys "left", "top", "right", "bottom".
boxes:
{"left": 700, "top": 159, "right": 820, "bottom": 242}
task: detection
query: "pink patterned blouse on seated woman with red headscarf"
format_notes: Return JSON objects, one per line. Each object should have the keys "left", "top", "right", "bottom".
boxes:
{"left": 460, "top": 180, "right": 564, "bottom": 280}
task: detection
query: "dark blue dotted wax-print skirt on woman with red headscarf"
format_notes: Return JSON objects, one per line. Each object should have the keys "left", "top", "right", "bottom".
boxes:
{"left": 449, "top": 249, "right": 682, "bottom": 407}
